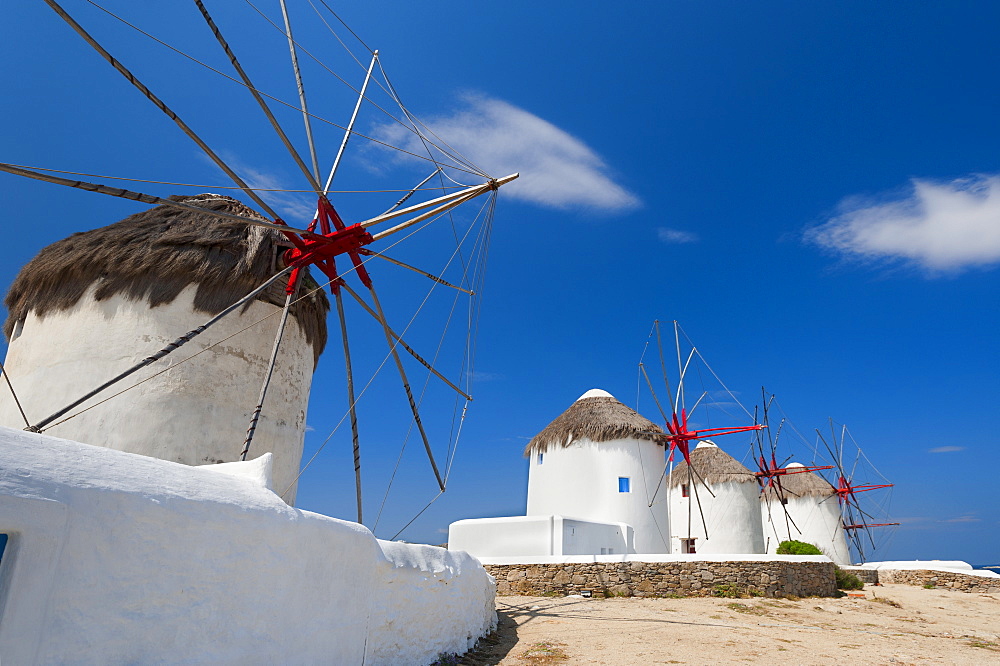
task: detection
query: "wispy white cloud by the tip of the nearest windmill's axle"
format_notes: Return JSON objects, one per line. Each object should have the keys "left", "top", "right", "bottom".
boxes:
{"left": 374, "top": 94, "right": 640, "bottom": 212}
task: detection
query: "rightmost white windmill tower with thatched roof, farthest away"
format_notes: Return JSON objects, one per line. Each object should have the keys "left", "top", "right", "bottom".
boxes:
{"left": 760, "top": 463, "right": 851, "bottom": 564}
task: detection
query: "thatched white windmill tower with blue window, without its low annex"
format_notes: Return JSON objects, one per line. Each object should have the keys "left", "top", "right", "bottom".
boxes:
{"left": 524, "top": 389, "right": 670, "bottom": 553}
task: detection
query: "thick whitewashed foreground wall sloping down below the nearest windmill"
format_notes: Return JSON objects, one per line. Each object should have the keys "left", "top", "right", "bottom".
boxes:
{"left": 0, "top": 428, "right": 494, "bottom": 664}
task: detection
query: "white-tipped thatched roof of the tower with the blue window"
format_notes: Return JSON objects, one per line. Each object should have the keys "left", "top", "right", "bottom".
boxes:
{"left": 524, "top": 389, "right": 663, "bottom": 457}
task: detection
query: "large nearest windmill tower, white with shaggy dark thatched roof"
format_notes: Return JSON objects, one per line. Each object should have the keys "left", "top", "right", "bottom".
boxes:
{"left": 0, "top": 194, "right": 329, "bottom": 503}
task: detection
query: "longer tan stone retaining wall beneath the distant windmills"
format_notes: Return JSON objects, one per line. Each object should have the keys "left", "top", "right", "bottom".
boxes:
{"left": 484, "top": 561, "right": 836, "bottom": 597}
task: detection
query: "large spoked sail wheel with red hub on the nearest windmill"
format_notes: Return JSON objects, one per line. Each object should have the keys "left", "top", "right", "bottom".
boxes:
{"left": 0, "top": 0, "right": 517, "bottom": 536}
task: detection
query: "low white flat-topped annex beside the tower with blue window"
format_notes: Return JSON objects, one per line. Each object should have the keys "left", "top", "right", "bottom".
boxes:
{"left": 448, "top": 516, "right": 634, "bottom": 558}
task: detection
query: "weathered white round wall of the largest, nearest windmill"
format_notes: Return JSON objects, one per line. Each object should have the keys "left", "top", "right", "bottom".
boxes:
{"left": 0, "top": 286, "right": 314, "bottom": 504}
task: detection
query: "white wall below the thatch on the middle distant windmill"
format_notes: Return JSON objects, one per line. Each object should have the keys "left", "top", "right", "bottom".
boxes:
{"left": 670, "top": 479, "right": 765, "bottom": 554}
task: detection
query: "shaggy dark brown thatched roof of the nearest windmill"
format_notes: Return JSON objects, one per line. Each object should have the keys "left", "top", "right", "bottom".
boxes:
{"left": 4, "top": 194, "right": 330, "bottom": 358}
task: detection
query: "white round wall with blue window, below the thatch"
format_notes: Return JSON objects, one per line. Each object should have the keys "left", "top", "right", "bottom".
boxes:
{"left": 527, "top": 438, "right": 670, "bottom": 553}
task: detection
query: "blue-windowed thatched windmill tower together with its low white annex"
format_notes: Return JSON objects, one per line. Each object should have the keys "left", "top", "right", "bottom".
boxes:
{"left": 448, "top": 389, "right": 670, "bottom": 557}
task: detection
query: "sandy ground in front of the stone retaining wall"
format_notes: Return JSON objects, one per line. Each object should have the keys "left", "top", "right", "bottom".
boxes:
{"left": 460, "top": 585, "right": 1000, "bottom": 666}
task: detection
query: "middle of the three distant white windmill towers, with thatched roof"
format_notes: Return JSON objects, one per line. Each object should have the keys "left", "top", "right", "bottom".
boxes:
{"left": 668, "top": 440, "right": 764, "bottom": 554}
